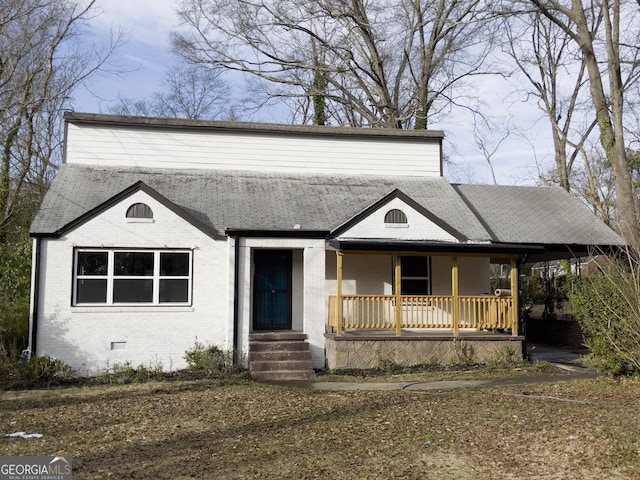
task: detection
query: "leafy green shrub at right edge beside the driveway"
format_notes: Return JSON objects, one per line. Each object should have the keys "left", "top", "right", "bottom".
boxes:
{"left": 570, "top": 263, "right": 640, "bottom": 375}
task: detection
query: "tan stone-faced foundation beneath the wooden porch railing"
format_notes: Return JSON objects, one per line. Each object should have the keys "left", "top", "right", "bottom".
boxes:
{"left": 325, "top": 330, "right": 524, "bottom": 370}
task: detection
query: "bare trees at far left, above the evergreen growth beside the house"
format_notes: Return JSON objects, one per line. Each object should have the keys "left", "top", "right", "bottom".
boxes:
{"left": 0, "top": 0, "right": 118, "bottom": 233}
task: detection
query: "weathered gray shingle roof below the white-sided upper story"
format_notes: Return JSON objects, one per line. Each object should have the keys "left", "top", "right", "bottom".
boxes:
{"left": 31, "top": 164, "right": 621, "bottom": 249}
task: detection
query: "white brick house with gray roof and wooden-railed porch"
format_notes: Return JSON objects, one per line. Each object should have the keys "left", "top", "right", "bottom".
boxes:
{"left": 30, "top": 113, "right": 623, "bottom": 378}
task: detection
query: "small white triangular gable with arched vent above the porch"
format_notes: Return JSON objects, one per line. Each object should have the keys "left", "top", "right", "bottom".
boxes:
{"left": 338, "top": 198, "right": 458, "bottom": 243}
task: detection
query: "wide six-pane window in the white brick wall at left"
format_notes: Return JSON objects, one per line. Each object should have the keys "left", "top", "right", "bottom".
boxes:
{"left": 73, "top": 249, "right": 192, "bottom": 305}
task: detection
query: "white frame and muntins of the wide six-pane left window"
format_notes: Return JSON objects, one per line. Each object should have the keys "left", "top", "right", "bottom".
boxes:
{"left": 71, "top": 248, "right": 193, "bottom": 308}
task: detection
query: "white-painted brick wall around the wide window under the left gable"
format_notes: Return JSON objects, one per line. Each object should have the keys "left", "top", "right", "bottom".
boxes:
{"left": 37, "top": 192, "right": 232, "bottom": 374}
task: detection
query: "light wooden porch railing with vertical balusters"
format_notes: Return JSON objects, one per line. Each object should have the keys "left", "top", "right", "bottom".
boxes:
{"left": 329, "top": 295, "right": 513, "bottom": 332}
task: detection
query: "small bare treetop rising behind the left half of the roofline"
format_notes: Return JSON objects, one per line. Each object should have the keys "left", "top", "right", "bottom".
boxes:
{"left": 109, "top": 64, "right": 231, "bottom": 120}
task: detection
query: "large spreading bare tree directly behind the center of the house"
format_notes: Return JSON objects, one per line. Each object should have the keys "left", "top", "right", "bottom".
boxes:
{"left": 173, "top": 0, "right": 498, "bottom": 128}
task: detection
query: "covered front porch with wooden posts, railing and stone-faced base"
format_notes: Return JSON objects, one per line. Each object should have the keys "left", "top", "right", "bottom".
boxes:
{"left": 325, "top": 246, "right": 524, "bottom": 369}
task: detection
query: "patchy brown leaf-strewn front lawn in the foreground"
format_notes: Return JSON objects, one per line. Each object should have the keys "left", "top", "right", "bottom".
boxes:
{"left": 0, "top": 378, "right": 640, "bottom": 480}
